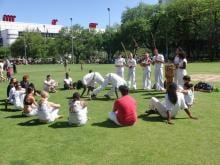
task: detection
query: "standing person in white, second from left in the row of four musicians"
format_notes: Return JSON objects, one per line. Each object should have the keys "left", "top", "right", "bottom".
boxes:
{"left": 127, "top": 53, "right": 137, "bottom": 90}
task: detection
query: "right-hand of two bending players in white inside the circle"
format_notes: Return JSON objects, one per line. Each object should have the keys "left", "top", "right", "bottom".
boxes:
{"left": 91, "top": 73, "right": 126, "bottom": 98}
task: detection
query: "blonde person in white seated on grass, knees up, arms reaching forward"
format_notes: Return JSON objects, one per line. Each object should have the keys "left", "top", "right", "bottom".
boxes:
{"left": 38, "top": 91, "right": 62, "bottom": 123}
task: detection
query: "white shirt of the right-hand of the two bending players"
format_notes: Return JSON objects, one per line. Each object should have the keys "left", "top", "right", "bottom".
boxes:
{"left": 105, "top": 73, "right": 126, "bottom": 88}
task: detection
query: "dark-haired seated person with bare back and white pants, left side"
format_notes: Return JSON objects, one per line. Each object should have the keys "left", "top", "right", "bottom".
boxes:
{"left": 22, "top": 87, "right": 38, "bottom": 116}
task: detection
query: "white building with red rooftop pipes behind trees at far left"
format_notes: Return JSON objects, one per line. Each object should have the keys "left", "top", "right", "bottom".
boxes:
{"left": 0, "top": 15, "right": 63, "bottom": 47}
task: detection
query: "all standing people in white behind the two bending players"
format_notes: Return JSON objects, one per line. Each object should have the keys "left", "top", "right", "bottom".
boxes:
{"left": 115, "top": 47, "right": 187, "bottom": 91}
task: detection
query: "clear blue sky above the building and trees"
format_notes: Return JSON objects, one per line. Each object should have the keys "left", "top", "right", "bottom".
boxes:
{"left": 0, "top": 0, "right": 158, "bottom": 28}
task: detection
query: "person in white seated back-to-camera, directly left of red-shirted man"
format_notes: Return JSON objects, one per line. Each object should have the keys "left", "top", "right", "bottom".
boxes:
{"left": 68, "top": 92, "right": 88, "bottom": 126}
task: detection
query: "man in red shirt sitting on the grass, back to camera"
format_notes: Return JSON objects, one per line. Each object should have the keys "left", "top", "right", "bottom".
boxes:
{"left": 109, "top": 85, "right": 137, "bottom": 126}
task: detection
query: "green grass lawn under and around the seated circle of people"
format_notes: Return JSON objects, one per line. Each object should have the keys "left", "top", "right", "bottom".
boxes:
{"left": 0, "top": 63, "right": 220, "bottom": 165}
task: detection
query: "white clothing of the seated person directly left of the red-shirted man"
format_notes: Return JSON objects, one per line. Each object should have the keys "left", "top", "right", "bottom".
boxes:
{"left": 69, "top": 100, "right": 88, "bottom": 125}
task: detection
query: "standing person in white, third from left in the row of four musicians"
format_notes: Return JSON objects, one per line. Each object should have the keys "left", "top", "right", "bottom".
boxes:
{"left": 140, "top": 52, "right": 151, "bottom": 89}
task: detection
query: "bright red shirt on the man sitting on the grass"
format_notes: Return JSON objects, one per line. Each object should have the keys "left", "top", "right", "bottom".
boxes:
{"left": 113, "top": 95, "right": 137, "bottom": 126}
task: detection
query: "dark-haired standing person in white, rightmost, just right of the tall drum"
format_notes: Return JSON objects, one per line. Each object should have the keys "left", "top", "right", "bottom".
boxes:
{"left": 177, "top": 52, "right": 187, "bottom": 87}
